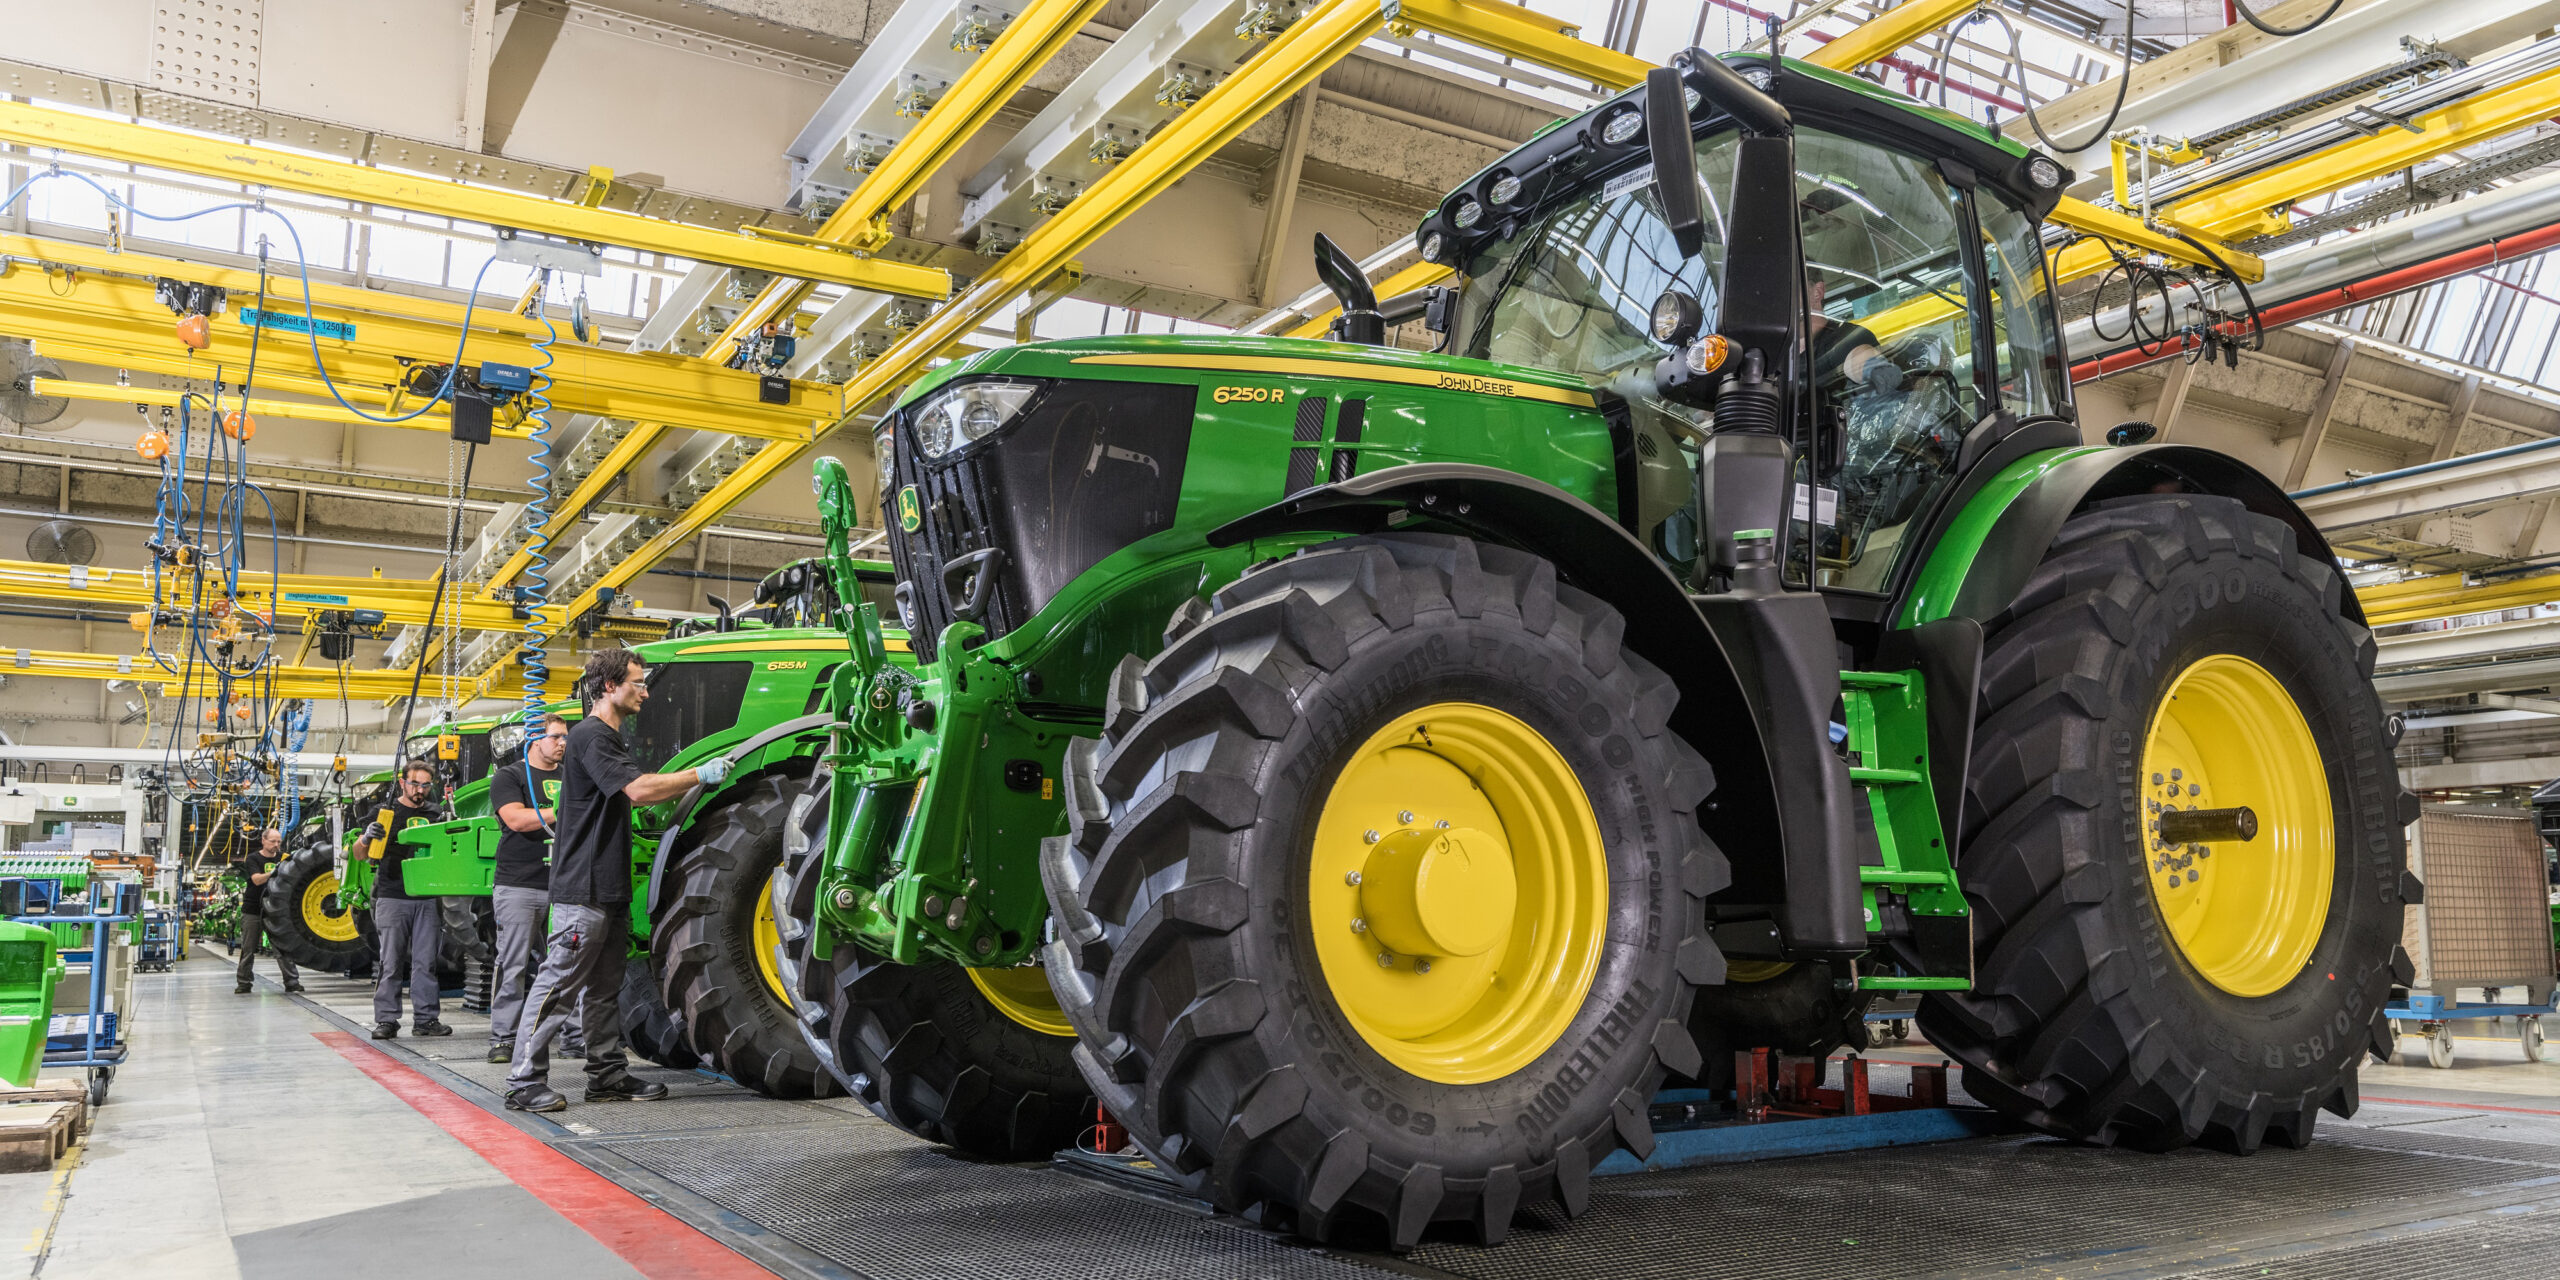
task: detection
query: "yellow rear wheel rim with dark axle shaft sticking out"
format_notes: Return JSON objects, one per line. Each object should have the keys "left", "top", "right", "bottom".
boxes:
{"left": 2140, "top": 653, "right": 2337, "bottom": 996}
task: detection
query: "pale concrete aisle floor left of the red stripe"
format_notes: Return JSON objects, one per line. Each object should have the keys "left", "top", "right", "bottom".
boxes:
{"left": 0, "top": 950, "right": 675, "bottom": 1280}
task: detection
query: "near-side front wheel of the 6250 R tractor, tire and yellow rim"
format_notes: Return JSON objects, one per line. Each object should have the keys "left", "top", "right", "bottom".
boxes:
{"left": 1042, "top": 535, "right": 1728, "bottom": 1249}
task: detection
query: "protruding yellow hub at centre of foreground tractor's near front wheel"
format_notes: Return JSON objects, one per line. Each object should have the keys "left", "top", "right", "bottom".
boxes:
{"left": 1359, "top": 827, "right": 1521, "bottom": 957}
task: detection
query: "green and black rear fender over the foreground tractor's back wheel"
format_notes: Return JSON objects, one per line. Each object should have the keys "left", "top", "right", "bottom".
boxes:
{"left": 1894, "top": 445, "right": 2365, "bottom": 627}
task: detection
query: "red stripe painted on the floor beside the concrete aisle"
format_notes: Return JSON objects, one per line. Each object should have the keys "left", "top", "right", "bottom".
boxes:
{"left": 312, "top": 1032, "right": 773, "bottom": 1280}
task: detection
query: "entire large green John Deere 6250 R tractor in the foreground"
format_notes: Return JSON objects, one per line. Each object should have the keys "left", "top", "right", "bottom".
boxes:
{"left": 786, "top": 51, "right": 2417, "bottom": 1247}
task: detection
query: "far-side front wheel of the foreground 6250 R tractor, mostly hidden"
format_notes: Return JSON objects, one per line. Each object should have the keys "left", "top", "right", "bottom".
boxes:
{"left": 776, "top": 778, "right": 1093, "bottom": 1160}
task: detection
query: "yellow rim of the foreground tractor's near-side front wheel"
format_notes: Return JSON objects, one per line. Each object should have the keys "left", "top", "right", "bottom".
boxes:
{"left": 1306, "top": 701, "right": 1608, "bottom": 1085}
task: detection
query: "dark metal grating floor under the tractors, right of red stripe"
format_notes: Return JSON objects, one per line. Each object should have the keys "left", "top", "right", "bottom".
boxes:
{"left": 264, "top": 962, "right": 2560, "bottom": 1280}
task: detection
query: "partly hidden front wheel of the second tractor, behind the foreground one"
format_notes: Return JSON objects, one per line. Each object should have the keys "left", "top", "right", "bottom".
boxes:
{"left": 650, "top": 773, "right": 835, "bottom": 1098}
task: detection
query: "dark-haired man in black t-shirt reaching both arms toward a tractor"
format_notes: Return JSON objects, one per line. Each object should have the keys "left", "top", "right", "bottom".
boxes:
{"left": 507, "top": 648, "right": 730, "bottom": 1111}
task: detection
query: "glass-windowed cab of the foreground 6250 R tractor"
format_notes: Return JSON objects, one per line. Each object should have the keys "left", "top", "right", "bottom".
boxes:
{"left": 1421, "top": 56, "right": 2071, "bottom": 594}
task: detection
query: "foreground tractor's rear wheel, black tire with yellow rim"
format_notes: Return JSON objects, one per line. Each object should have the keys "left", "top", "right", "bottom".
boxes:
{"left": 1920, "top": 497, "right": 2414, "bottom": 1152}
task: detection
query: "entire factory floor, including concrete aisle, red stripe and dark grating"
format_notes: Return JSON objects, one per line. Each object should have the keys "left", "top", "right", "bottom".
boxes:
{"left": 0, "top": 950, "right": 2560, "bottom": 1280}
